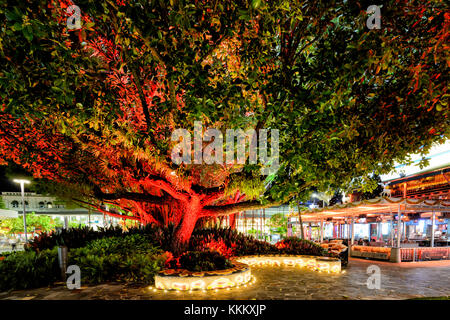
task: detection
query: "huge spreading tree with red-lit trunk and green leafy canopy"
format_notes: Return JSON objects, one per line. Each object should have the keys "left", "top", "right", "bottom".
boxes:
{"left": 0, "top": 0, "right": 450, "bottom": 248}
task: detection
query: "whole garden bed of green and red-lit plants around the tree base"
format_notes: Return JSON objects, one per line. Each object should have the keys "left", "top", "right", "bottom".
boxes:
{"left": 0, "top": 226, "right": 338, "bottom": 291}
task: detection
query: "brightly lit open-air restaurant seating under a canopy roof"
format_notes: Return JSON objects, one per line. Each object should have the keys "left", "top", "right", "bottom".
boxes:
{"left": 294, "top": 182, "right": 450, "bottom": 263}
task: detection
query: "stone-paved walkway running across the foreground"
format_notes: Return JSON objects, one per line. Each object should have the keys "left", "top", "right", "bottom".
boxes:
{"left": 0, "top": 259, "right": 450, "bottom": 300}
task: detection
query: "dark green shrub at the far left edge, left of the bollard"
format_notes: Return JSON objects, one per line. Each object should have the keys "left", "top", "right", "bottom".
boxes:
{"left": 0, "top": 248, "right": 61, "bottom": 291}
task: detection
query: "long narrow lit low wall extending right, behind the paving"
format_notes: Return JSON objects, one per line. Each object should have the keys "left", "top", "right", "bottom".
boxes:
{"left": 236, "top": 255, "right": 341, "bottom": 273}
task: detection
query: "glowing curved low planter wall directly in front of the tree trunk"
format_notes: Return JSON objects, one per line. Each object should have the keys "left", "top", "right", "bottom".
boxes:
{"left": 155, "top": 261, "right": 252, "bottom": 291}
